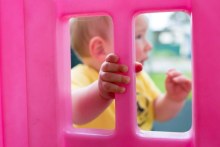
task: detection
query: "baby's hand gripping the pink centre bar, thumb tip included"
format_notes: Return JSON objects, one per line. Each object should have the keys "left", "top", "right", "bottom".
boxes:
{"left": 98, "top": 54, "right": 142, "bottom": 99}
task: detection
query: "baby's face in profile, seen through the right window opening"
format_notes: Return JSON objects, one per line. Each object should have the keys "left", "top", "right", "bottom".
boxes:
{"left": 135, "top": 15, "right": 152, "bottom": 64}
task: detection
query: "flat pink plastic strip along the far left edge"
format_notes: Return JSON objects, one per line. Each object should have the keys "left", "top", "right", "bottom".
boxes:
{"left": 0, "top": 0, "right": 28, "bottom": 147}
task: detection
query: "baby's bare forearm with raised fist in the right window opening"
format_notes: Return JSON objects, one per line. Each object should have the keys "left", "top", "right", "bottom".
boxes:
{"left": 154, "top": 69, "right": 192, "bottom": 121}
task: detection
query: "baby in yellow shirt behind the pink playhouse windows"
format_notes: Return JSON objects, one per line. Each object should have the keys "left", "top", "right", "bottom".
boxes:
{"left": 71, "top": 15, "right": 191, "bottom": 130}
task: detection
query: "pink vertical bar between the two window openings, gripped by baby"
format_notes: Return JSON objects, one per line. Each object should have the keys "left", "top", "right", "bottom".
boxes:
{"left": 113, "top": 11, "right": 137, "bottom": 134}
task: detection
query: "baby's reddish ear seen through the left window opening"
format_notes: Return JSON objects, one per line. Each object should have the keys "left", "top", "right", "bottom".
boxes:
{"left": 89, "top": 36, "right": 106, "bottom": 62}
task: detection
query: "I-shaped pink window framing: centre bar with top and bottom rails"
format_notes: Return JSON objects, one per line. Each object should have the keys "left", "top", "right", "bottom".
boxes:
{"left": 60, "top": 0, "right": 192, "bottom": 147}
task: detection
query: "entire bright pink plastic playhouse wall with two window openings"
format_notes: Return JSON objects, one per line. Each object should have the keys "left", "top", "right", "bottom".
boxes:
{"left": 0, "top": 0, "right": 220, "bottom": 147}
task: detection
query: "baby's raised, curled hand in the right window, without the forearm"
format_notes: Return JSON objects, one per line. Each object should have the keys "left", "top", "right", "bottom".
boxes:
{"left": 165, "top": 69, "right": 192, "bottom": 101}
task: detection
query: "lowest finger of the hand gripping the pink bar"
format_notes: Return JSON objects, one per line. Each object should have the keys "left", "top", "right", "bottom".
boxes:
{"left": 101, "top": 81, "right": 125, "bottom": 93}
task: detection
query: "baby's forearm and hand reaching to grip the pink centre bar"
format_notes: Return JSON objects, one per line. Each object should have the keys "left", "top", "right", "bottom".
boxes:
{"left": 72, "top": 54, "right": 142, "bottom": 124}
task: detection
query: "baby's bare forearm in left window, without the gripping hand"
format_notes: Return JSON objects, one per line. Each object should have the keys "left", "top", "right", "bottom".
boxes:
{"left": 72, "top": 81, "right": 112, "bottom": 125}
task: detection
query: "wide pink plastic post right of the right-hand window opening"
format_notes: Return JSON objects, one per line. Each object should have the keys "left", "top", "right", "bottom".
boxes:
{"left": 192, "top": 0, "right": 220, "bottom": 147}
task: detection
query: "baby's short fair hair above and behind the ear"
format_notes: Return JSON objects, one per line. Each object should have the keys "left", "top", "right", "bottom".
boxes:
{"left": 70, "top": 16, "right": 112, "bottom": 58}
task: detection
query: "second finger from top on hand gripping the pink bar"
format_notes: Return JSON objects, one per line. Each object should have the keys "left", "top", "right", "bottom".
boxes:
{"left": 101, "top": 62, "right": 128, "bottom": 72}
